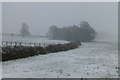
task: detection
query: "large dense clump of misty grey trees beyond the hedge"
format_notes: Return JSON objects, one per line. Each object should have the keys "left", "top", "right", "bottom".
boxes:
{"left": 48, "top": 21, "right": 97, "bottom": 42}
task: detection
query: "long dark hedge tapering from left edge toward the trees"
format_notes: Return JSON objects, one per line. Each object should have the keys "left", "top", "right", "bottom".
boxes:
{"left": 2, "top": 42, "right": 78, "bottom": 61}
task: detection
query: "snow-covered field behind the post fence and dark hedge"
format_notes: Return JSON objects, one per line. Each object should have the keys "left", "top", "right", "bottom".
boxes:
{"left": 2, "top": 35, "right": 68, "bottom": 46}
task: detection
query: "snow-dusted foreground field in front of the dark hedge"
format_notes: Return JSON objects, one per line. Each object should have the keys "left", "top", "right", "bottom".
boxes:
{"left": 2, "top": 42, "right": 118, "bottom": 78}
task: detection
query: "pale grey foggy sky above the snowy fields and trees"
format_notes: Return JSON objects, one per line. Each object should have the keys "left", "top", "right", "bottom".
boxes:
{"left": 2, "top": 2, "right": 118, "bottom": 39}
